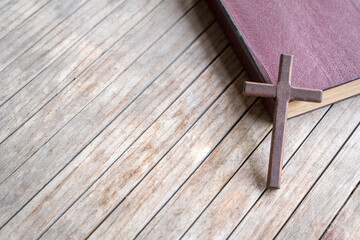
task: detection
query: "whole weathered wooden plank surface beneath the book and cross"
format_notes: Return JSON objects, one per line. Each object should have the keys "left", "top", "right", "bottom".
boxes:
{"left": 0, "top": 0, "right": 360, "bottom": 239}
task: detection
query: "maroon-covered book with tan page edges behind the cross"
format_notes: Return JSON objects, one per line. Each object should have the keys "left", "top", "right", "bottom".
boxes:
{"left": 207, "top": 0, "right": 360, "bottom": 118}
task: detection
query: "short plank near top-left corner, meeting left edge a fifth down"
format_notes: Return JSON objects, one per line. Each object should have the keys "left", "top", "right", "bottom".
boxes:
{"left": 0, "top": 0, "right": 87, "bottom": 71}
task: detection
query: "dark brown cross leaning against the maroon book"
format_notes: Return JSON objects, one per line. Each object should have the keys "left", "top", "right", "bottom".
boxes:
{"left": 244, "top": 54, "right": 322, "bottom": 188}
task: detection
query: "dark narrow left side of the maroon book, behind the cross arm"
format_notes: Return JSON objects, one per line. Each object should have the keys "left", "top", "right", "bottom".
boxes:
{"left": 206, "top": 0, "right": 275, "bottom": 117}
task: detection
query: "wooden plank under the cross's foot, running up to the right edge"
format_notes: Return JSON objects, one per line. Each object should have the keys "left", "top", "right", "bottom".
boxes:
{"left": 231, "top": 97, "right": 360, "bottom": 239}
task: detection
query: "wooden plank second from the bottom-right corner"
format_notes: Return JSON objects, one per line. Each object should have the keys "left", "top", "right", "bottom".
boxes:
{"left": 276, "top": 124, "right": 360, "bottom": 239}
